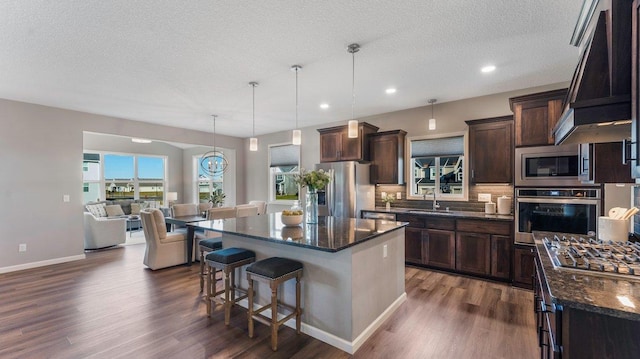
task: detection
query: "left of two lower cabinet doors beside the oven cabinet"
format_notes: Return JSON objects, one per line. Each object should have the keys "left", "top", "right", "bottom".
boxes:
{"left": 456, "top": 232, "right": 491, "bottom": 275}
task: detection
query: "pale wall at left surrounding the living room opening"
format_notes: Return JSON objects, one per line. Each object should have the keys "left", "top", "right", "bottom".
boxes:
{"left": 0, "top": 99, "right": 245, "bottom": 272}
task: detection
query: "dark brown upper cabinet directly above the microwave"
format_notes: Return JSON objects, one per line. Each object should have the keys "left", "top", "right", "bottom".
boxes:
{"left": 509, "top": 89, "right": 567, "bottom": 147}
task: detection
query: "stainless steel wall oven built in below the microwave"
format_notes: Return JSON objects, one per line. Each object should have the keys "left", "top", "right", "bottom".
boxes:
{"left": 515, "top": 187, "right": 601, "bottom": 244}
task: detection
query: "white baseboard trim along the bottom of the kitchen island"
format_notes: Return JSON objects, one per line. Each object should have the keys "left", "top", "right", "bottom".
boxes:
{"left": 238, "top": 292, "right": 407, "bottom": 354}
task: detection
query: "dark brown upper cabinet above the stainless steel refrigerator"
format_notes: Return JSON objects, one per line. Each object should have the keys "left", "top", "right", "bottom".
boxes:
{"left": 318, "top": 122, "right": 378, "bottom": 162}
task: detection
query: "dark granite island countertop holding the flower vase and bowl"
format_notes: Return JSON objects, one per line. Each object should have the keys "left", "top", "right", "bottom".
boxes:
{"left": 187, "top": 212, "right": 406, "bottom": 252}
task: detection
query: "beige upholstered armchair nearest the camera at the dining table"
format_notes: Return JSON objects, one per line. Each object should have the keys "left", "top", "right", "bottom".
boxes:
{"left": 140, "top": 209, "right": 187, "bottom": 270}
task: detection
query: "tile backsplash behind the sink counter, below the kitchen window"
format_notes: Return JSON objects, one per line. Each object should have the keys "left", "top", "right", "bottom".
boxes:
{"left": 376, "top": 185, "right": 514, "bottom": 213}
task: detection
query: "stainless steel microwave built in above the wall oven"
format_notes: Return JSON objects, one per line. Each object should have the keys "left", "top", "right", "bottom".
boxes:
{"left": 514, "top": 144, "right": 582, "bottom": 187}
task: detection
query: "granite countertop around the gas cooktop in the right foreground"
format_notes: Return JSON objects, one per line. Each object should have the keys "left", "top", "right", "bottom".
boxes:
{"left": 533, "top": 232, "right": 640, "bottom": 320}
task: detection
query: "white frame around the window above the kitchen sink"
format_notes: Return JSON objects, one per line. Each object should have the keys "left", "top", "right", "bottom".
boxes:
{"left": 404, "top": 131, "right": 469, "bottom": 201}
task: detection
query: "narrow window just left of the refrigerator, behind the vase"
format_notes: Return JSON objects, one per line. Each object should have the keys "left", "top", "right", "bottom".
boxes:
{"left": 269, "top": 145, "right": 300, "bottom": 201}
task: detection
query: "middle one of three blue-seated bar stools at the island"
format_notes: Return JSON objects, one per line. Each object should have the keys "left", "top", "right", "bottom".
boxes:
{"left": 206, "top": 247, "right": 256, "bottom": 325}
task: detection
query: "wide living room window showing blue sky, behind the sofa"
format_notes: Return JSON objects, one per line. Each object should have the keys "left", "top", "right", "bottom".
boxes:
{"left": 82, "top": 153, "right": 166, "bottom": 203}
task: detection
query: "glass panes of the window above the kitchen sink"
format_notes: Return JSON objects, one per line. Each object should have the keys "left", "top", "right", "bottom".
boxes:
{"left": 410, "top": 136, "right": 466, "bottom": 199}
